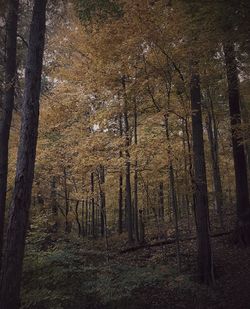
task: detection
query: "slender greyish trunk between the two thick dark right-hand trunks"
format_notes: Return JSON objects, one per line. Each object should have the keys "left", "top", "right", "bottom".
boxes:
{"left": 207, "top": 92, "right": 224, "bottom": 228}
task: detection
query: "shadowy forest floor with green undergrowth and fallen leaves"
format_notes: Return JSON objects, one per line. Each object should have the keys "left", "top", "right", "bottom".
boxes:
{"left": 22, "top": 213, "right": 250, "bottom": 309}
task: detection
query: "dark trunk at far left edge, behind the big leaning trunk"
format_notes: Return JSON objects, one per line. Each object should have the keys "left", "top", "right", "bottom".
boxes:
{"left": 0, "top": 0, "right": 19, "bottom": 270}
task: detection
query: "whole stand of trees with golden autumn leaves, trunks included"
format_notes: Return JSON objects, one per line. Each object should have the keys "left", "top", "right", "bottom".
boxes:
{"left": 0, "top": 0, "right": 250, "bottom": 308}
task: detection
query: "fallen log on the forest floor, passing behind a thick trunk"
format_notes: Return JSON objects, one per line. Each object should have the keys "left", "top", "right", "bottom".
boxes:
{"left": 119, "top": 230, "right": 233, "bottom": 254}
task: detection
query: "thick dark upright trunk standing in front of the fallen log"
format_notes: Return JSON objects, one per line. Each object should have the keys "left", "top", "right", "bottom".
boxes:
{"left": 191, "top": 74, "right": 214, "bottom": 284}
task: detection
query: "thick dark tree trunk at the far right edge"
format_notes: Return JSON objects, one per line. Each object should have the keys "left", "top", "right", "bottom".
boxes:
{"left": 223, "top": 41, "right": 250, "bottom": 245}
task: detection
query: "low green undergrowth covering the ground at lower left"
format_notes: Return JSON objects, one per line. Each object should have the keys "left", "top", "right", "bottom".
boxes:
{"left": 22, "top": 221, "right": 179, "bottom": 309}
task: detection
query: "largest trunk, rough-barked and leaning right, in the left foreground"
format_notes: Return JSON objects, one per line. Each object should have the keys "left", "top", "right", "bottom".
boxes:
{"left": 0, "top": 0, "right": 47, "bottom": 309}
